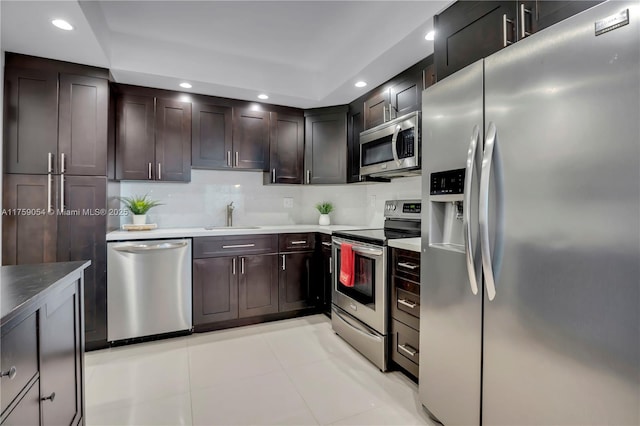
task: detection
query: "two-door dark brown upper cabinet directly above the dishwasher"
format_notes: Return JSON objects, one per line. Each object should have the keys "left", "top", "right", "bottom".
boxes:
{"left": 116, "top": 93, "right": 191, "bottom": 182}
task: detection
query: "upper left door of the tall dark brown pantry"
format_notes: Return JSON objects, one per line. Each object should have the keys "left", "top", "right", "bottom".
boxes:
{"left": 4, "top": 68, "right": 58, "bottom": 174}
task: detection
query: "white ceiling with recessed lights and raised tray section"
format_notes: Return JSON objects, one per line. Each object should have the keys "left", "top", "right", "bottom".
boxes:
{"left": 0, "top": 0, "right": 451, "bottom": 108}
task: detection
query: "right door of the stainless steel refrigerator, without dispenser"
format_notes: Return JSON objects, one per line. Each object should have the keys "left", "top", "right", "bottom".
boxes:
{"left": 482, "top": 1, "right": 640, "bottom": 425}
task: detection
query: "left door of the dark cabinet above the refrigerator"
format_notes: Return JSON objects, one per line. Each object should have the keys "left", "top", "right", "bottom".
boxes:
{"left": 434, "top": 1, "right": 516, "bottom": 80}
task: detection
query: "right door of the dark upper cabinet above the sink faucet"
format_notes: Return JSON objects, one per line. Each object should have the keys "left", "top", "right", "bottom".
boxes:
{"left": 231, "top": 109, "right": 269, "bottom": 172}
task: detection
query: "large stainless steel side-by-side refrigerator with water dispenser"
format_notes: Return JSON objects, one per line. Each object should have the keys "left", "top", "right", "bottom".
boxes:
{"left": 419, "top": 1, "right": 640, "bottom": 425}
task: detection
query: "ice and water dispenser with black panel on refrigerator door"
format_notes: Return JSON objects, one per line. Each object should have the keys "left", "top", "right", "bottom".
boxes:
{"left": 429, "top": 169, "right": 465, "bottom": 253}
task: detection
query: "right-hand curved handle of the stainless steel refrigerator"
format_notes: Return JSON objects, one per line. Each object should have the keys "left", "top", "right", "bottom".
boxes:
{"left": 478, "top": 122, "right": 497, "bottom": 300}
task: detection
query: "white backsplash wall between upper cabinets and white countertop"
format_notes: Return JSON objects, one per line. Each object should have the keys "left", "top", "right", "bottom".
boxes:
{"left": 120, "top": 169, "right": 421, "bottom": 227}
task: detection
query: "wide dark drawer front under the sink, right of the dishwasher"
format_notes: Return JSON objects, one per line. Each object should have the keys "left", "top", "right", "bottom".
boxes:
{"left": 193, "top": 234, "right": 278, "bottom": 259}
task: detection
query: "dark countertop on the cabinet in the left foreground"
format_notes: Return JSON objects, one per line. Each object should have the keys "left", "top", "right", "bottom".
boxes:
{"left": 0, "top": 260, "right": 91, "bottom": 325}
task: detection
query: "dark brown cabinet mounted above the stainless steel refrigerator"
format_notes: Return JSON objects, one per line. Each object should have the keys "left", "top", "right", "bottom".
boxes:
{"left": 434, "top": 0, "right": 600, "bottom": 80}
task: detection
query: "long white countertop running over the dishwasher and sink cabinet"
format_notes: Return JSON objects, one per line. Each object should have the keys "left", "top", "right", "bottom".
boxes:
{"left": 107, "top": 225, "right": 370, "bottom": 241}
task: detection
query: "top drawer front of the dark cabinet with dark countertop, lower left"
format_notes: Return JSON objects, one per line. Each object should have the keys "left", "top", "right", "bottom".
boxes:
{"left": 0, "top": 313, "right": 38, "bottom": 412}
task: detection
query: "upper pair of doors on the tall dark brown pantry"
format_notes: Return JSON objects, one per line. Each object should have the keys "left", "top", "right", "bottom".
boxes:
{"left": 5, "top": 67, "right": 109, "bottom": 176}
